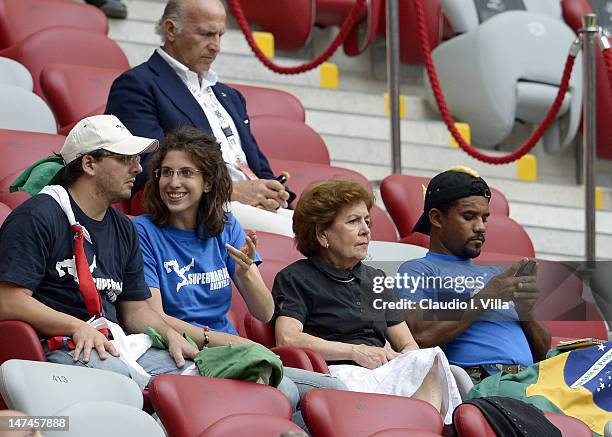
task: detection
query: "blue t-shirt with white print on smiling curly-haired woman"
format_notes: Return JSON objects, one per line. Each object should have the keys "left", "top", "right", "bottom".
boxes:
{"left": 134, "top": 213, "right": 261, "bottom": 335}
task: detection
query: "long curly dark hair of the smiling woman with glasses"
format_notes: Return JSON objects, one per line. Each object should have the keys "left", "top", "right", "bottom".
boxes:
{"left": 144, "top": 126, "right": 232, "bottom": 238}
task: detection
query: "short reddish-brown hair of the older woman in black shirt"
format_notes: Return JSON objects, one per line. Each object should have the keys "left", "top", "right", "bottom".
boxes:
{"left": 293, "top": 178, "right": 374, "bottom": 257}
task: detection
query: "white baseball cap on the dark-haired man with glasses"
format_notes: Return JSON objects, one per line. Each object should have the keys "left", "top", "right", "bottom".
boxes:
{"left": 60, "top": 115, "right": 159, "bottom": 164}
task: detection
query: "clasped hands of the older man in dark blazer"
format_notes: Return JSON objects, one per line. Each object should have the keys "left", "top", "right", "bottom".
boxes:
{"left": 232, "top": 172, "right": 289, "bottom": 211}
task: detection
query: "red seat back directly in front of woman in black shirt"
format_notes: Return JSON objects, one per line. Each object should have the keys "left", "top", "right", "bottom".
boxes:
{"left": 300, "top": 389, "right": 443, "bottom": 437}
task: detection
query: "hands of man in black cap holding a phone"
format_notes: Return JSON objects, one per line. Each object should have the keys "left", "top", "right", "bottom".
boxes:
{"left": 476, "top": 258, "right": 539, "bottom": 316}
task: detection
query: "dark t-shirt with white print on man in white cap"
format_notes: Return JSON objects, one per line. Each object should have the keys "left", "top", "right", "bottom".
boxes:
{"left": 0, "top": 194, "right": 151, "bottom": 322}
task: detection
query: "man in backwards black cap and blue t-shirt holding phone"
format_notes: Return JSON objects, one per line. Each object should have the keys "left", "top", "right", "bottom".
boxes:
{"left": 395, "top": 167, "right": 550, "bottom": 382}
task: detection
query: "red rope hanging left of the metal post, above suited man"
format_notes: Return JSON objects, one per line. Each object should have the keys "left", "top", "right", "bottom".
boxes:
{"left": 227, "top": 0, "right": 367, "bottom": 74}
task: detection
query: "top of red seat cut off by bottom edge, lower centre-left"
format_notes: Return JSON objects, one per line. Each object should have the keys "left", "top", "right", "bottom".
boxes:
{"left": 198, "top": 414, "right": 302, "bottom": 437}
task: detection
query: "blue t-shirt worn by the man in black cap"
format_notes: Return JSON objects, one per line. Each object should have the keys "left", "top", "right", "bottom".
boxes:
{"left": 395, "top": 252, "right": 533, "bottom": 367}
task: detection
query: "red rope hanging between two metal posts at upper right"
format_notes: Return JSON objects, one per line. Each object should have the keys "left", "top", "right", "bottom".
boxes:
{"left": 414, "top": 0, "right": 580, "bottom": 164}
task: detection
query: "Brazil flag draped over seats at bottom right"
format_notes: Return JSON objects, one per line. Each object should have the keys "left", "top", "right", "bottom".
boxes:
{"left": 468, "top": 342, "right": 612, "bottom": 435}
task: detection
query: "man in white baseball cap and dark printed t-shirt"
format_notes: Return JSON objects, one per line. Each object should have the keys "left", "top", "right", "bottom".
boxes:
{"left": 0, "top": 115, "right": 197, "bottom": 376}
